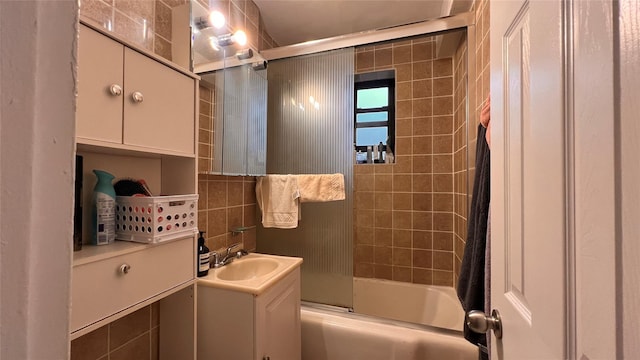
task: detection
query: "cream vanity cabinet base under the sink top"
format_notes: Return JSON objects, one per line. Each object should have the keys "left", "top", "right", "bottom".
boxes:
{"left": 198, "top": 267, "right": 301, "bottom": 360}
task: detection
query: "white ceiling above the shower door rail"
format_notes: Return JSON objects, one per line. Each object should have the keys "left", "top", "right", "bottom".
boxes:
{"left": 253, "top": 0, "right": 473, "bottom": 46}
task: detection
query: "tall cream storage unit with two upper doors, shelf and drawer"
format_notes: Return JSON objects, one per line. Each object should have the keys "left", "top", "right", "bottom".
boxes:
{"left": 70, "top": 24, "right": 199, "bottom": 359}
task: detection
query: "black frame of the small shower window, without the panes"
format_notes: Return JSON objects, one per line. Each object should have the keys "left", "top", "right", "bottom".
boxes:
{"left": 353, "top": 70, "right": 396, "bottom": 152}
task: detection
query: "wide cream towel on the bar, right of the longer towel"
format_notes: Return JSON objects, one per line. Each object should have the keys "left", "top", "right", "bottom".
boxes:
{"left": 295, "top": 174, "right": 345, "bottom": 202}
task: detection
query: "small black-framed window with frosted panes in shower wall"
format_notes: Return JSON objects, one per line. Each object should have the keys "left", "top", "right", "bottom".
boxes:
{"left": 354, "top": 70, "right": 395, "bottom": 162}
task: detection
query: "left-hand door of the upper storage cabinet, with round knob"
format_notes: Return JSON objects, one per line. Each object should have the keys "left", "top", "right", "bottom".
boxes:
{"left": 76, "top": 25, "right": 124, "bottom": 144}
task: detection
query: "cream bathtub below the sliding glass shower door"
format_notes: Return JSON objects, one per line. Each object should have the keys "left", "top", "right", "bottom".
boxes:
{"left": 301, "top": 279, "right": 478, "bottom": 360}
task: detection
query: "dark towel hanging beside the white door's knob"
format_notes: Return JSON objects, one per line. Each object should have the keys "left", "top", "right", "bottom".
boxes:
{"left": 457, "top": 125, "right": 490, "bottom": 352}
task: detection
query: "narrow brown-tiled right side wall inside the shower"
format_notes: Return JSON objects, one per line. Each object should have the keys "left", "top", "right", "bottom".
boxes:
{"left": 453, "top": 35, "right": 475, "bottom": 285}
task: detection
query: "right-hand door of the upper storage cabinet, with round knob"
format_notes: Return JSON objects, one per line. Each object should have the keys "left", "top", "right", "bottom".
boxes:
{"left": 123, "top": 49, "right": 195, "bottom": 154}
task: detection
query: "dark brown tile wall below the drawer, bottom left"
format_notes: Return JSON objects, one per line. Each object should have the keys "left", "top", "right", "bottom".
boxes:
{"left": 71, "top": 302, "right": 160, "bottom": 360}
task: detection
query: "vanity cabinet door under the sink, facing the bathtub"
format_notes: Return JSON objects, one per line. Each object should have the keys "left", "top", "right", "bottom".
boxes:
{"left": 255, "top": 269, "right": 302, "bottom": 360}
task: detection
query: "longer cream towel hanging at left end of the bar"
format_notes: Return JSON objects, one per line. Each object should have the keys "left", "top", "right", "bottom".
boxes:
{"left": 256, "top": 175, "right": 300, "bottom": 229}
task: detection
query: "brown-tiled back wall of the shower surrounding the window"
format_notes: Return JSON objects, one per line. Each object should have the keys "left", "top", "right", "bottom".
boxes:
{"left": 354, "top": 37, "right": 454, "bottom": 286}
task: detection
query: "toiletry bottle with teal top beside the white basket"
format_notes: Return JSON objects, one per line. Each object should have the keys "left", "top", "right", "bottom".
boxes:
{"left": 91, "top": 170, "right": 116, "bottom": 245}
